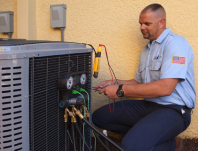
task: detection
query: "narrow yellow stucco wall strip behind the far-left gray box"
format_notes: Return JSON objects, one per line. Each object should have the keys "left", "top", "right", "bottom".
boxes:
{"left": 0, "top": 0, "right": 17, "bottom": 38}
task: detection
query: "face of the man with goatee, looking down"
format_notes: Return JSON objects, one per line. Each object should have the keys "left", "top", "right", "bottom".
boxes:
{"left": 139, "top": 10, "right": 161, "bottom": 41}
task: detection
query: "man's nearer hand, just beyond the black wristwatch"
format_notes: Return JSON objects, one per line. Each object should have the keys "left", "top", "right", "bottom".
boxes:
{"left": 99, "top": 85, "right": 119, "bottom": 99}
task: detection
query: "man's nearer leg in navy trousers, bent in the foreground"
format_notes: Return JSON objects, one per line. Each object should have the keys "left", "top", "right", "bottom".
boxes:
{"left": 121, "top": 108, "right": 190, "bottom": 151}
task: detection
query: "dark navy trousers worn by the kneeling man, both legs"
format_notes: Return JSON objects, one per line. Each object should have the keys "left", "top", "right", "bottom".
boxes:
{"left": 92, "top": 100, "right": 191, "bottom": 151}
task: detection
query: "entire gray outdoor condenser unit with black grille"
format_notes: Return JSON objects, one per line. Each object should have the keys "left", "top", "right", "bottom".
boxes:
{"left": 0, "top": 40, "right": 92, "bottom": 151}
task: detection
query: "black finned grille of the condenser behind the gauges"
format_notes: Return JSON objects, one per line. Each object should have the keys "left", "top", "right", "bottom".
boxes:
{"left": 29, "top": 53, "right": 91, "bottom": 151}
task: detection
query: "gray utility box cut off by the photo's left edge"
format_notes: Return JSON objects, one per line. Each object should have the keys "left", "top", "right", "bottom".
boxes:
{"left": 0, "top": 11, "right": 14, "bottom": 33}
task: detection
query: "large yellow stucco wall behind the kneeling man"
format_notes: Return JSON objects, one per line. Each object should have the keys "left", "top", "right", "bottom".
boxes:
{"left": 0, "top": 0, "right": 198, "bottom": 138}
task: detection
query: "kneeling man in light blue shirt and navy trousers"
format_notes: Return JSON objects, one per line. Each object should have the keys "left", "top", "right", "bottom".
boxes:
{"left": 93, "top": 4, "right": 196, "bottom": 151}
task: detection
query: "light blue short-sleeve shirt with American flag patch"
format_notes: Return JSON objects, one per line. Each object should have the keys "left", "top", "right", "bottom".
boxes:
{"left": 135, "top": 28, "right": 196, "bottom": 108}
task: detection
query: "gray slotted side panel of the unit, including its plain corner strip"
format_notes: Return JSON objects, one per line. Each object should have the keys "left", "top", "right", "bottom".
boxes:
{"left": 0, "top": 59, "right": 29, "bottom": 151}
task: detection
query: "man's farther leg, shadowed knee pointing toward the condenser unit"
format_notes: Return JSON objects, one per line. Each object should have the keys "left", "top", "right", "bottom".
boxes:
{"left": 92, "top": 100, "right": 148, "bottom": 136}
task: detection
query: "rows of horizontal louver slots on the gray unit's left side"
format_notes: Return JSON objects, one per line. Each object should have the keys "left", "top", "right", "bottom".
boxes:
{"left": 0, "top": 60, "right": 27, "bottom": 151}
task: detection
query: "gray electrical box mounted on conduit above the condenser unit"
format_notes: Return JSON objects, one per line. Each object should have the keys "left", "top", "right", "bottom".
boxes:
{"left": 50, "top": 4, "right": 67, "bottom": 28}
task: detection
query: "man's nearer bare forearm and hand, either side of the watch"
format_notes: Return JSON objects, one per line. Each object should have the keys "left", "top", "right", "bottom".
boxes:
{"left": 99, "top": 78, "right": 179, "bottom": 99}
